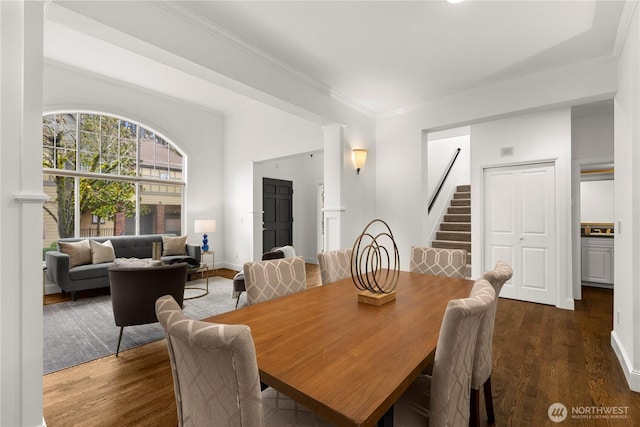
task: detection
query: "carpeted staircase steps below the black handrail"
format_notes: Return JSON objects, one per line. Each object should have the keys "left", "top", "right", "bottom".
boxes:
{"left": 431, "top": 185, "right": 471, "bottom": 271}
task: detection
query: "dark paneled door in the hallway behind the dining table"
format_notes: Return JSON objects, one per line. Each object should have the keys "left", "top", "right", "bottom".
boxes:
{"left": 262, "top": 178, "right": 293, "bottom": 252}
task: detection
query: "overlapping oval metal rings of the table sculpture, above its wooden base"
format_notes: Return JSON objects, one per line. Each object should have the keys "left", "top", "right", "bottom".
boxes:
{"left": 351, "top": 219, "right": 400, "bottom": 294}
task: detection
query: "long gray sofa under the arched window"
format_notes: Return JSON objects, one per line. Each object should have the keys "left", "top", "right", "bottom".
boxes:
{"left": 45, "top": 234, "right": 201, "bottom": 301}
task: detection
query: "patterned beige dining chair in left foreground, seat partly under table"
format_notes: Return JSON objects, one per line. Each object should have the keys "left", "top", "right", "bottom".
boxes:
{"left": 155, "top": 295, "right": 330, "bottom": 427}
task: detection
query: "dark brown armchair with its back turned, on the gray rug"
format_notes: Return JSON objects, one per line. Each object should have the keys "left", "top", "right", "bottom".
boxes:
{"left": 109, "top": 262, "right": 188, "bottom": 357}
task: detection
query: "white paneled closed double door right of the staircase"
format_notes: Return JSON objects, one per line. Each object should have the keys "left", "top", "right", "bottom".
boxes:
{"left": 483, "top": 163, "right": 557, "bottom": 305}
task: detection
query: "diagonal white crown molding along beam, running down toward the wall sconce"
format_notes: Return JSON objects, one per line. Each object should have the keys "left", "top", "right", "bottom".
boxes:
{"left": 152, "top": 0, "right": 377, "bottom": 118}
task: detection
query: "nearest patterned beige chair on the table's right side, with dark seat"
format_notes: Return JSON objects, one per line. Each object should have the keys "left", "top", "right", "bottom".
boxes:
{"left": 393, "top": 279, "right": 495, "bottom": 427}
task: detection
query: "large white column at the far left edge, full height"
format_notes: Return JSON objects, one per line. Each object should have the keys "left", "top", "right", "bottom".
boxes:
{"left": 0, "top": 1, "right": 46, "bottom": 426}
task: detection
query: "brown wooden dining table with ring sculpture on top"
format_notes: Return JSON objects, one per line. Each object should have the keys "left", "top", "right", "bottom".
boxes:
{"left": 205, "top": 272, "right": 473, "bottom": 426}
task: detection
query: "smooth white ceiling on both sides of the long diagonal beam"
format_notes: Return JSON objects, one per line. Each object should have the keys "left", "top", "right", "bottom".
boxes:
{"left": 45, "top": 0, "right": 624, "bottom": 115}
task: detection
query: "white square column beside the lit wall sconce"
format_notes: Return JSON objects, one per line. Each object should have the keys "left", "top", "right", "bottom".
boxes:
{"left": 322, "top": 123, "right": 345, "bottom": 251}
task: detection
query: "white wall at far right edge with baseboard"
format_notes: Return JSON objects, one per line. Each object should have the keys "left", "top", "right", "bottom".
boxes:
{"left": 611, "top": 3, "right": 640, "bottom": 391}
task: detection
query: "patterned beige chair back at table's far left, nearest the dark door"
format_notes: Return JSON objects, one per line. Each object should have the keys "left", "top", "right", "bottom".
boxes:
{"left": 242, "top": 257, "right": 307, "bottom": 305}
